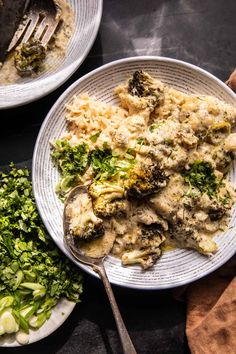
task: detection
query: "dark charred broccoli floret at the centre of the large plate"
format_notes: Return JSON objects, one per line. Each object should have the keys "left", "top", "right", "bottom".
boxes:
{"left": 125, "top": 164, "right": 168, "bottom": 199}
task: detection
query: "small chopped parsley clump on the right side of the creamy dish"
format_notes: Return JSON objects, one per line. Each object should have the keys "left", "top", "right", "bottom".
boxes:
{"left": 182, "top": 161, "right": 220, "bottom": 197}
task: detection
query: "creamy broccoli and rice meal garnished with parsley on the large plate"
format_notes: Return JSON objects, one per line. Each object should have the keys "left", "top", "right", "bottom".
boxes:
{"left": 52, "top": 70, "right": 236, "bottom": 269}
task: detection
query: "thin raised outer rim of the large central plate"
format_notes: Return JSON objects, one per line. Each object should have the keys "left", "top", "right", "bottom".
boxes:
{"left": 32, "top": 56, "right": 236, "bottom": 291}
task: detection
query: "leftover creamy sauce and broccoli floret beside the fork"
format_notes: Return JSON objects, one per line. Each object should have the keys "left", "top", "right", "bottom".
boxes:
{"left": 0, "top": 0, "right": 74, "bottom": 84}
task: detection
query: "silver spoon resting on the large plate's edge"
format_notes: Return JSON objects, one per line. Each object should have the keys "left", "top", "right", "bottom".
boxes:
{"left": 63, "top": 186, "right": 137, "bottom": 354}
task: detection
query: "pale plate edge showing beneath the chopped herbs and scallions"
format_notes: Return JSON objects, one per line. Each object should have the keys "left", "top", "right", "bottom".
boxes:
{"left": 0, "top": 298, "right": 75, "bottom": 347}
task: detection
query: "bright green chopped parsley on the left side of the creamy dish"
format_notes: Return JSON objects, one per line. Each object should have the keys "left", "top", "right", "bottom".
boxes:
{"left": 52, "top": 140, "right": 135, "bottom": 196}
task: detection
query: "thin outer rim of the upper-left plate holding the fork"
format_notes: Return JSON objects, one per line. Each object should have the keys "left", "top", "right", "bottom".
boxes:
{"left": 0, "top": 0, "right": 103, "bottom": 110}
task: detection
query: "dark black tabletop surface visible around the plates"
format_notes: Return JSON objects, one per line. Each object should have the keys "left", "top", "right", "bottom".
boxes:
{"left": 0, "top": 0, "right": 236, "bottom": 354}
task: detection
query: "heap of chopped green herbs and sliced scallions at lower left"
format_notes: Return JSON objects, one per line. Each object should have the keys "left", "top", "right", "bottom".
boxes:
{"left": 0, "top": 166, "right": 82, "bottom": 344}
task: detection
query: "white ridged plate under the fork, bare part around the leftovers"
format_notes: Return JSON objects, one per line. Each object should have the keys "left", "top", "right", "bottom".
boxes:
{"left": 0, "top": 0, "right": 103, "bottom": 109}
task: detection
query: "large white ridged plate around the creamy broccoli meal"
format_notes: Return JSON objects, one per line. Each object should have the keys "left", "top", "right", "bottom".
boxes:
{"left": 33, "top": 57, "right": 236, "bottom": 289}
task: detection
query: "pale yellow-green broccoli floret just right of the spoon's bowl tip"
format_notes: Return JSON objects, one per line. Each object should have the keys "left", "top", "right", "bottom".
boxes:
{"left": 88, "top": 182, "right": 127, "bottom": 217}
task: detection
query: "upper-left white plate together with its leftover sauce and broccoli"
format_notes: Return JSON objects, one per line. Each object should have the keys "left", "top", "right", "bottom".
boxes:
{"left": 0, "top": 0, "right": 102, "bottom": 109}
